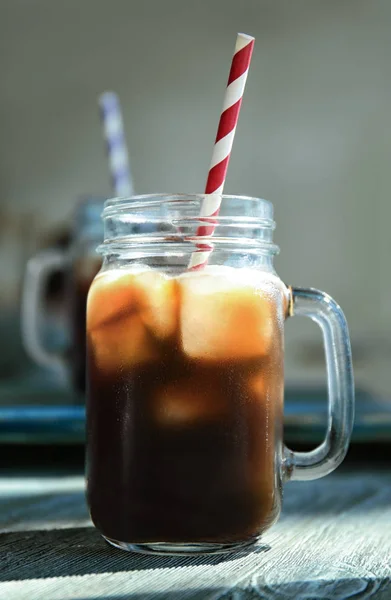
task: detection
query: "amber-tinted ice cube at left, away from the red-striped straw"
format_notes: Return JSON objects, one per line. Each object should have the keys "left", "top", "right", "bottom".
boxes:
{"left": 87, "top": 270, "right": 178, "bottom": 372}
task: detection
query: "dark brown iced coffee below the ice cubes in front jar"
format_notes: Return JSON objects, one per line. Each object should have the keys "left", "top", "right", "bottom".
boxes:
{"left": 87, "top": 270, "right": 283, "bottom": 543}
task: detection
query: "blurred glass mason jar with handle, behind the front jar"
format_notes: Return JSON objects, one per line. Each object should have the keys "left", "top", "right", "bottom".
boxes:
{"left": 21, "top": 196, "right": 104, "bottom": 393}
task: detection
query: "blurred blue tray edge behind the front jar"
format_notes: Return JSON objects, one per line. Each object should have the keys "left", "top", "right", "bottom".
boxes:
{"left": 0, "top": 384, "right": 391, "bottom": 444}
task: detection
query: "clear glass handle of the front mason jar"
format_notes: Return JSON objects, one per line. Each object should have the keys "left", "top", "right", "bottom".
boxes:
{"left": 284, "top": 288, "right": 354, "bottom": 480}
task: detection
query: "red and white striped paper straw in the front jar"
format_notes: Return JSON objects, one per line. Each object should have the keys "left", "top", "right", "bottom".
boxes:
{"left": 189, "top": 33, "right": 254, "bottom": 270}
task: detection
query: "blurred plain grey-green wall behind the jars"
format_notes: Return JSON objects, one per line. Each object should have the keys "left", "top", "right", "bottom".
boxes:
{"left": 0, "top": 0, "right": 391, "bottom": 398}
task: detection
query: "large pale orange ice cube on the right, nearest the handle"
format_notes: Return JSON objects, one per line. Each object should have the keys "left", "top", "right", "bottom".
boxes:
{"left": 180, "top": 269, "right": 278, "bottom": 360}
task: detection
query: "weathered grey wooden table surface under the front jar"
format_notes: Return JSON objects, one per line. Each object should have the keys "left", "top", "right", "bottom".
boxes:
{"left": 0, "top": 468, "right": 391, "bottom": 600}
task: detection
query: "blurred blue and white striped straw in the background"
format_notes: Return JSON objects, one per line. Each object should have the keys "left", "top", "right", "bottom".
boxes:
{"left": 99, "top": 92, "right": 134, "bottom": 196}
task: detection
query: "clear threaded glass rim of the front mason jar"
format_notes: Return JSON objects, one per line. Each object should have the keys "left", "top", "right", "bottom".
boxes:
{"left": 99, "top": 193, "right": 278, "bottom": 254}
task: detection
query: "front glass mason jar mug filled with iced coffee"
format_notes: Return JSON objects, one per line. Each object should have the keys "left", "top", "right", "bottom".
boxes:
{"left": 87, "top": 195, "right": 354, "bottom": 553}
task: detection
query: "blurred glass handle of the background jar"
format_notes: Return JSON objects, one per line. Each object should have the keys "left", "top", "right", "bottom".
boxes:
{"left": 21, "top": 249, "right": 68, "bottom": 381}
